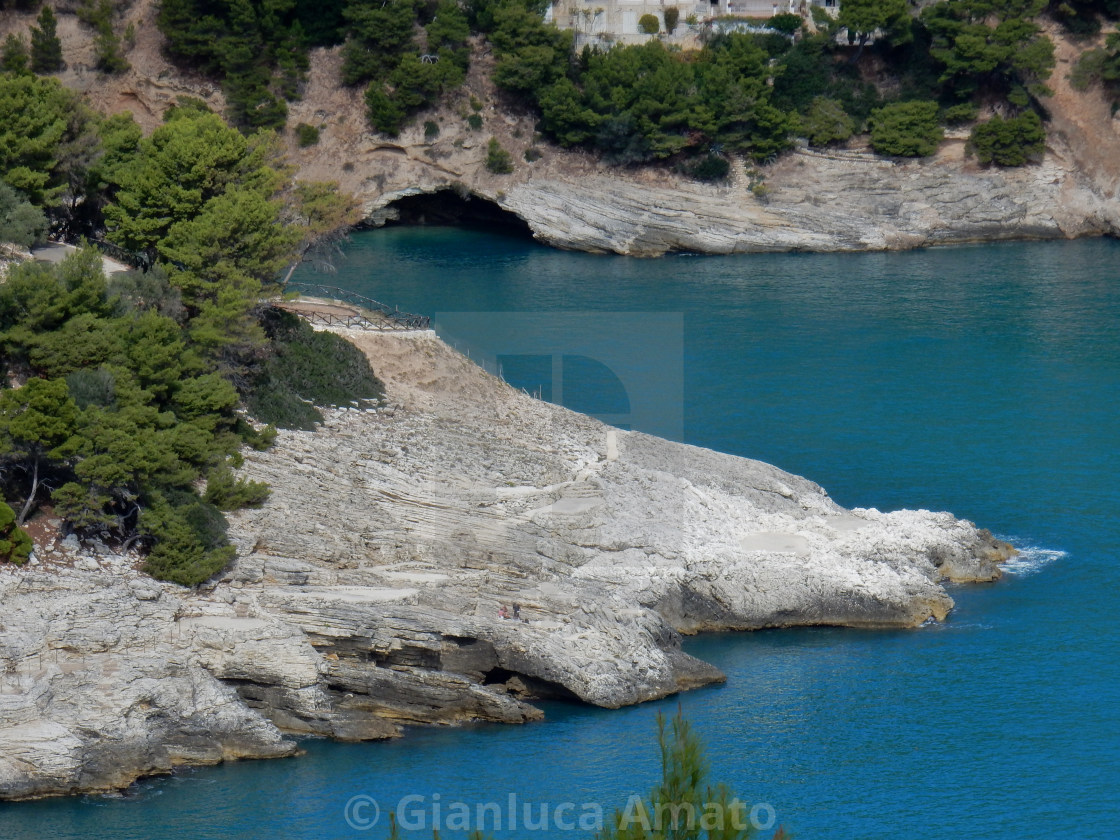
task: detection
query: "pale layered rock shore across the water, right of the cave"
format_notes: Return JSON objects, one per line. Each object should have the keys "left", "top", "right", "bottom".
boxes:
{"left": 497, "top": 141, "right": 1120, "bottom": 256}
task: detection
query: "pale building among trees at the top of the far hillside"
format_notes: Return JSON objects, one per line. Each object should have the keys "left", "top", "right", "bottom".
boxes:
{"left": 545, "top": 0, "right": 840, "bottom": 44}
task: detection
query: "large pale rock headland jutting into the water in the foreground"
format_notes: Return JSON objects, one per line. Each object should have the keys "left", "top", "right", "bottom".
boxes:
{"left": 0, "top": 333, "right": 1002, "bottom": 799}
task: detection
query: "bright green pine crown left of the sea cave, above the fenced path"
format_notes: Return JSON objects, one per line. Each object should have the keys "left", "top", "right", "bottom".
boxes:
{"left": 105, "top": 110, "right": 300, "bottom": 365}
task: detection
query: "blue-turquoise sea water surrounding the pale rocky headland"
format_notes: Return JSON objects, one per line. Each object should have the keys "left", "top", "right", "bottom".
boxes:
{"left": 0, "top": 228, "right": 1120, "bottom": 840}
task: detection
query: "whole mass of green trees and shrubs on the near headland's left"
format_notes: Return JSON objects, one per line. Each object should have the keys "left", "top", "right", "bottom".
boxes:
{"left": 0, "top": 74, "right": 381, "bottom": 585}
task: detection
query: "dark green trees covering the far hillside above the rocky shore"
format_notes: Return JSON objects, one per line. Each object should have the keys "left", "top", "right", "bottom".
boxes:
{"left": 2, "top": 0, "right": 1120, "bottom": 172}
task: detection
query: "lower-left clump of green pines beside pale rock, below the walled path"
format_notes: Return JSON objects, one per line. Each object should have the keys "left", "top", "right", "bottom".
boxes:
{"left": 0, "top": 250, "right": 263, "bottom": 582}
